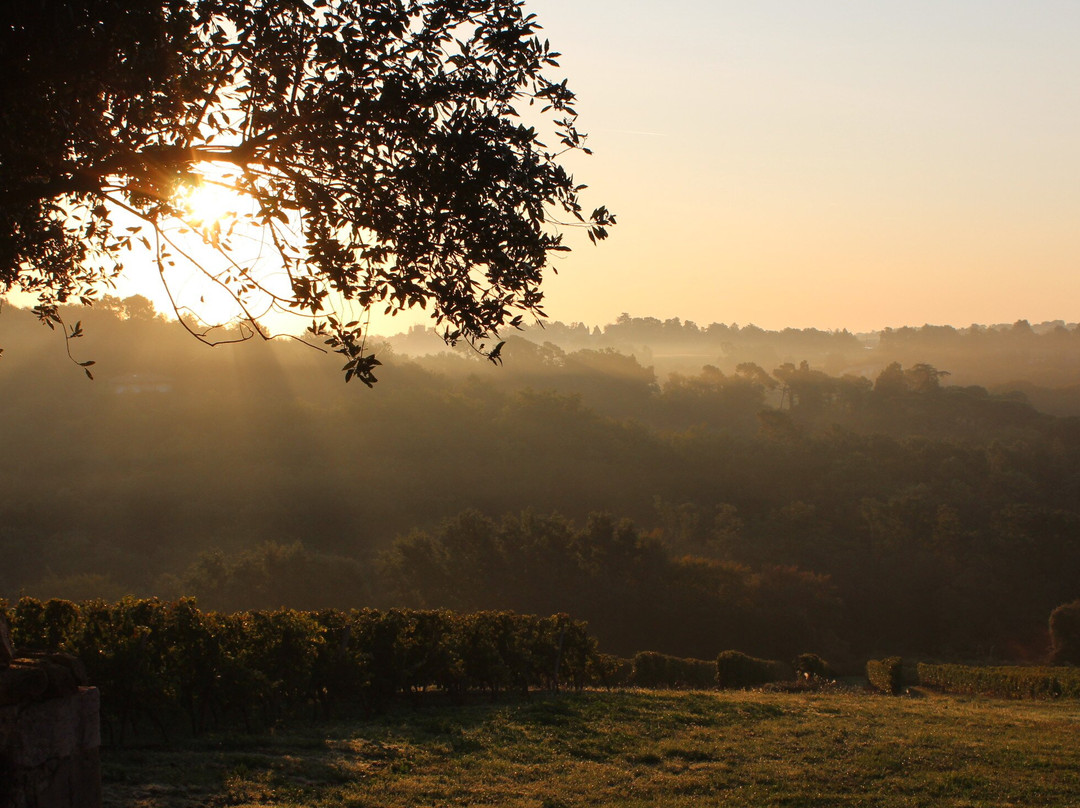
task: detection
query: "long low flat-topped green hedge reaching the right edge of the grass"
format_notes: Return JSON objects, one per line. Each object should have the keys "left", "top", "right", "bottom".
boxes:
{"left": 918, "top": 662, "right": 1080, "bottom": 699}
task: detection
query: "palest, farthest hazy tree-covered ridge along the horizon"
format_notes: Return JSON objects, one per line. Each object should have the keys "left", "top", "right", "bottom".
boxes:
{"left": 391, "top": 314, "right": 1080, "bottom": 395}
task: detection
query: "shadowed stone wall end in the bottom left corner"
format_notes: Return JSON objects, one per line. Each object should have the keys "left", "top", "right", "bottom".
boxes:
{"left": 0, "top": 620, "right": 102, "bottom": 808}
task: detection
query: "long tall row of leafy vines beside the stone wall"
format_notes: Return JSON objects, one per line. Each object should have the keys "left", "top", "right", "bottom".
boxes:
{"left": 0, "top": 597, "right": 609, "bottom": 742}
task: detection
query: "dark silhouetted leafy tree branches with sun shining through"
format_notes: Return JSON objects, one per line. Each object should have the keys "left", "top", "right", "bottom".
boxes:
{"left": 0, "top": 0, "right": 612, "bottom": 383}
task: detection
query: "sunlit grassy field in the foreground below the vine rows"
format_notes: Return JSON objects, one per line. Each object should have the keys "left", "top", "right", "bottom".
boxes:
{"left": 103, "top": 691, "right": 1080, "bottom": 808}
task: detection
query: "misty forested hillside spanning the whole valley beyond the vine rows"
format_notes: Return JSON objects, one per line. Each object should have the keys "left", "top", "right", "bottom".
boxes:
{"left": 0, "top": 299, "right": 1080, "bottom": 659}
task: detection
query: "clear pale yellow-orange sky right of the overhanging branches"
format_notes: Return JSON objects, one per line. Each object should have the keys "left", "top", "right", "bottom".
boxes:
{"left": 531, "top": 0, "right": 1080, "bottom": 329}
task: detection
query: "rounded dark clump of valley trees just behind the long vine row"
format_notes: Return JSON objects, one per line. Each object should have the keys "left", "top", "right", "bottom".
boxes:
{"left": 379, "top": 512, "right": 841, "bottom": 659}
